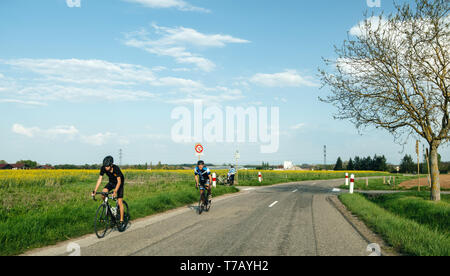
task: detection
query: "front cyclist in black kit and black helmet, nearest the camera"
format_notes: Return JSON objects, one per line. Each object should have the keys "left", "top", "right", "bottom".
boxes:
{"left": 92, "top": 156, "right": 125, "bottom": 230}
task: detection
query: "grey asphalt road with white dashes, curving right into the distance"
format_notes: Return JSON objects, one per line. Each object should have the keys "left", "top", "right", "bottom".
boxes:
{"left": 26, "top": 180, "right": 368, "bottom": 256}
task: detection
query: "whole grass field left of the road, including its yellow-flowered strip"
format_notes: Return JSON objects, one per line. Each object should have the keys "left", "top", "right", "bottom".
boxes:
{"left": 0, "top": 170, "right": 383, "bottom": 255}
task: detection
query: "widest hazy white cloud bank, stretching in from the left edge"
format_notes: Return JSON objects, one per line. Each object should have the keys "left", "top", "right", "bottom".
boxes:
{"left": 0, "top": 59, "right": 207, "bottom": 105}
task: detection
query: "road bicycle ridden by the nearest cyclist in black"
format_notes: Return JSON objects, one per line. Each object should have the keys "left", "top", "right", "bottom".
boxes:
{"left": 92, "top": 192, "right": 130, "bottom": 239}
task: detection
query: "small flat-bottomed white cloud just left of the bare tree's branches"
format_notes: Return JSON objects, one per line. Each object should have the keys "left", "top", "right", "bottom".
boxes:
{"left": 250, "top": 70, "right": 318, "bottom": 87}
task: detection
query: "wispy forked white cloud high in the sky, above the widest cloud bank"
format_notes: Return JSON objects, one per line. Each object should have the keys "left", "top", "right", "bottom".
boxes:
{"left": 125, "top": 24, "right": 249, "bottom": 72}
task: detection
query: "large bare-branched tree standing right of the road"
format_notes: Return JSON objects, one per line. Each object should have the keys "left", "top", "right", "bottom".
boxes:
{"left": 319, "top": 0, "right": 450, "bottom": 201}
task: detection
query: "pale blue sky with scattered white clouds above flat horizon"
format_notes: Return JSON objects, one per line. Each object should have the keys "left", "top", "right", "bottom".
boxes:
{"left": 0, "top": 0, "right": 450, "bottom": 164}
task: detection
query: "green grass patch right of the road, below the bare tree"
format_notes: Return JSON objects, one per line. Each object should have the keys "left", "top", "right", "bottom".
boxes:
{"left": 339, "top": 192, "right": 450, "bottom": 256}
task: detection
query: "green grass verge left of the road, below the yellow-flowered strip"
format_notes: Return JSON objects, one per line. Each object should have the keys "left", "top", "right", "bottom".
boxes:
{"left": 0, "top": 175, "right": 238, "bottom": 256}
